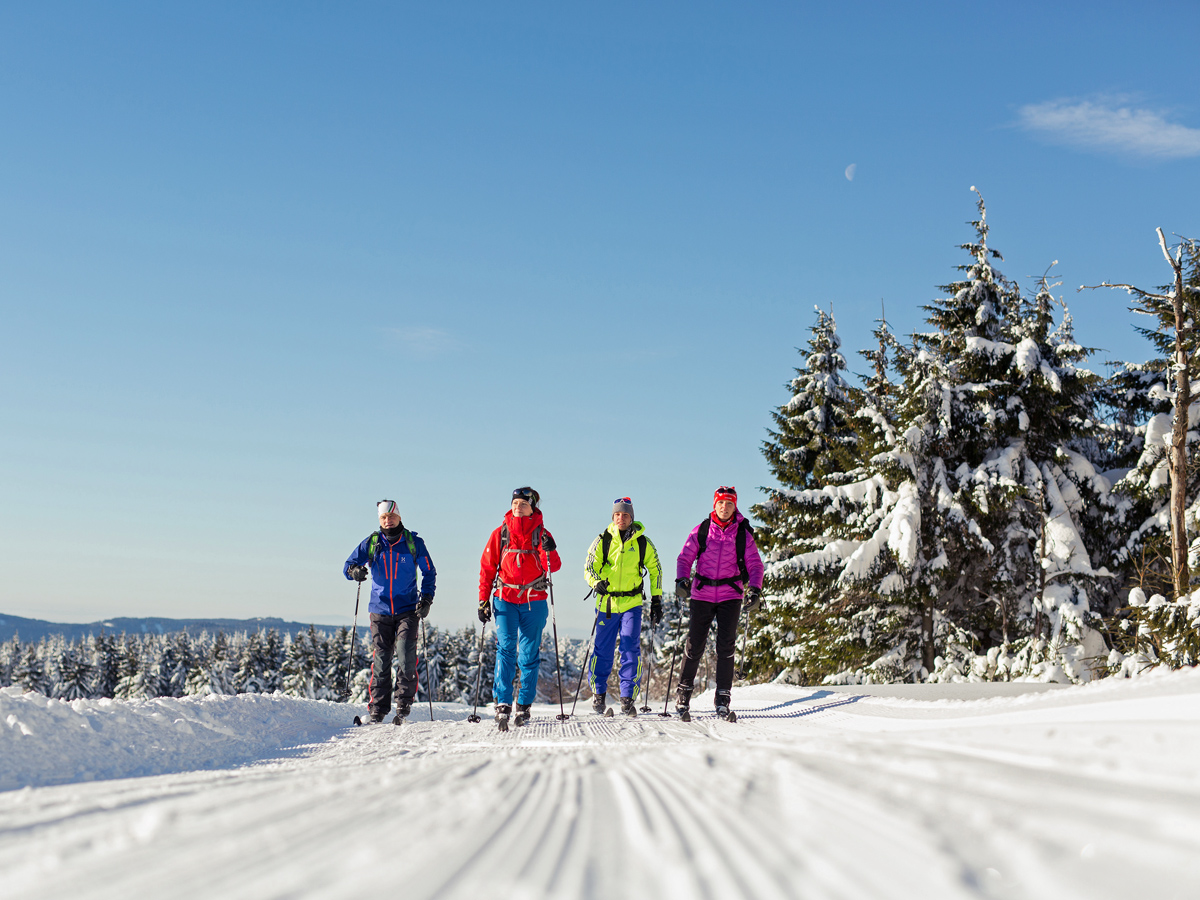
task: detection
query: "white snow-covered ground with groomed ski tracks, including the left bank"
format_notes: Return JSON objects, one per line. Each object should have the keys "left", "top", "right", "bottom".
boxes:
{"left": 0, "top": 672, "right": 1200, "bottom": 900}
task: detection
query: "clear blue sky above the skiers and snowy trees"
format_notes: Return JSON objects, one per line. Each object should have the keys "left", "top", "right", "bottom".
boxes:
{"left": 0, "top": 2, "right": 1200, "bottom": 634}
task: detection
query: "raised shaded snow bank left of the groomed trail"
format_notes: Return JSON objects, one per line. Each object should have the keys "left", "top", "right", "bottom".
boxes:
{"left": 0, "top": 686, "right": 350, "bottom": 791}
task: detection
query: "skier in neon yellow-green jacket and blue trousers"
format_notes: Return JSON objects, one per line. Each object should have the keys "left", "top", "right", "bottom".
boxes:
{"left": 583, "top": 497, "right": 662, "bottom": 715}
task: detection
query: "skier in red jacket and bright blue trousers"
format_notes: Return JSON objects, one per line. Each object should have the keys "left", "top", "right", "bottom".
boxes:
{"left": 479, "top": 487, "right": 563, "bottom": 731}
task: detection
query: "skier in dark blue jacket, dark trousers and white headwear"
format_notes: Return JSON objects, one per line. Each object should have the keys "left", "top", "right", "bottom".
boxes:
{"left": 343, "top": 500, "right": 438, "bottom": 725}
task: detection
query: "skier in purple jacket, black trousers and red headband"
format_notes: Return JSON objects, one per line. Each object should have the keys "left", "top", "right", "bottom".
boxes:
{"left": 676, "top": 487, "right": 763, "bottom": 720}
